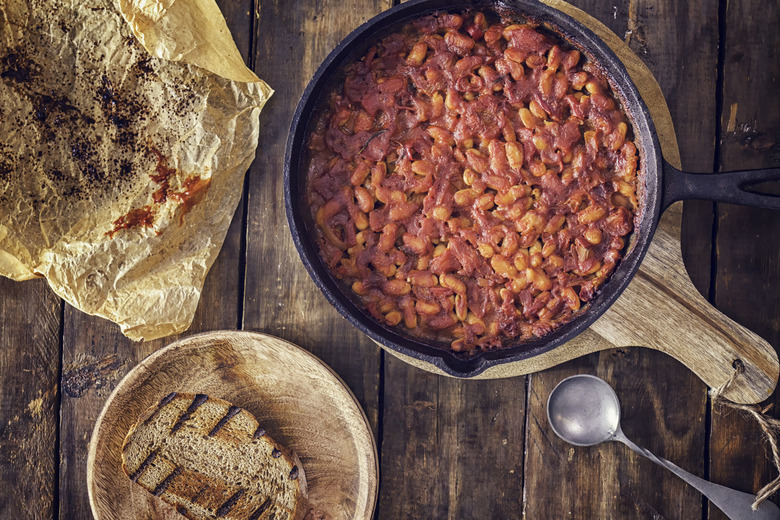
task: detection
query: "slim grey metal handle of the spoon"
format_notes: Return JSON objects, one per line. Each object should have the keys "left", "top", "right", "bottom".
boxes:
{"left": 612, "top": 430, "right": 780, "bottom": 520}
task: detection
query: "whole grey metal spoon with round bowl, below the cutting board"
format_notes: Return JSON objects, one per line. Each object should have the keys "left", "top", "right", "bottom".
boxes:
{"left": 547, "top": 375, "right": 780, "bottom": 520}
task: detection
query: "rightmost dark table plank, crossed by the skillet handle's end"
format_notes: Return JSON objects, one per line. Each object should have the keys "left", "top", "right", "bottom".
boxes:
{"left": 710, "top": 0, "right": 780, "bottom": 519}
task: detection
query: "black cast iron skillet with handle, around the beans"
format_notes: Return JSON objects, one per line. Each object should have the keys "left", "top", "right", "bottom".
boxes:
{"left": 284, "top": 0, "right": 780, "bottom": 377}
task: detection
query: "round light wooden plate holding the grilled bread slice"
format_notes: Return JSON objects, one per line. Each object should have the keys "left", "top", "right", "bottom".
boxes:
{"left": 87, "top": 331, "right": 378, "bottom": 520}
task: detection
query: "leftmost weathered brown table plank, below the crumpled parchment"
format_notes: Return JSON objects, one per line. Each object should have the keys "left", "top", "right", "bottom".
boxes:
{"left": 0, "top": 277, "right": 62, "bottom": 520}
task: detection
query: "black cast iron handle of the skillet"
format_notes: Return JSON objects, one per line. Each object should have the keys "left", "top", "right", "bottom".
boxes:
{"left": 661, "top": 161, "right": 780, "bottom": 211}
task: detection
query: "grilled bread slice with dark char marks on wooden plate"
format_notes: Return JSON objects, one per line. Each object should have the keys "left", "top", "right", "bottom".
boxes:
{"left": 122, "top": 393, "right": 306, "bottom": 520}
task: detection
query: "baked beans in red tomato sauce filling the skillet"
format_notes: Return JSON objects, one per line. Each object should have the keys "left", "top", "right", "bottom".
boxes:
{"left": 305, "top": 12, "right": 640, "bottom": 353}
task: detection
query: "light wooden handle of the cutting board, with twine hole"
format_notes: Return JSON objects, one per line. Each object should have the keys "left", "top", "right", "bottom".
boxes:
{"left": 592, "top": 203, "right": 780, "bottom": 403}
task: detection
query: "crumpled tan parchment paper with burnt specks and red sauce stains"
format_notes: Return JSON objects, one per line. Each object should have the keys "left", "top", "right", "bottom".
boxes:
{"left": 0, "top": 0, "right": 273, "bottom": 340}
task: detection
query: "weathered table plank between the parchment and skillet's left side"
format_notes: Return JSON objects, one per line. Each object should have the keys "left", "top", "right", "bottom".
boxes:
{"left": 243, "top": 0, "right": 391, "bottom": 431}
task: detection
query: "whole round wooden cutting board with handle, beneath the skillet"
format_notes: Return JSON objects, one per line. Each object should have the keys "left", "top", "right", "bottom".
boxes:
{"left": 380, "top": 0, "right": 780, "bottom": 403}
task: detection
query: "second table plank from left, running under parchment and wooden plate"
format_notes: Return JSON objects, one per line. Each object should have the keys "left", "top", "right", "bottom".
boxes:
{"left": 59, "top": 0, "right": 253, "bottom": 520}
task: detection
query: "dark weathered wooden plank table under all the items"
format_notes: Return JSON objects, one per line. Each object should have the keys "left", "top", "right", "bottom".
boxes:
{"left": 0, "top": 0, "right": 780, "bottom": 519}
